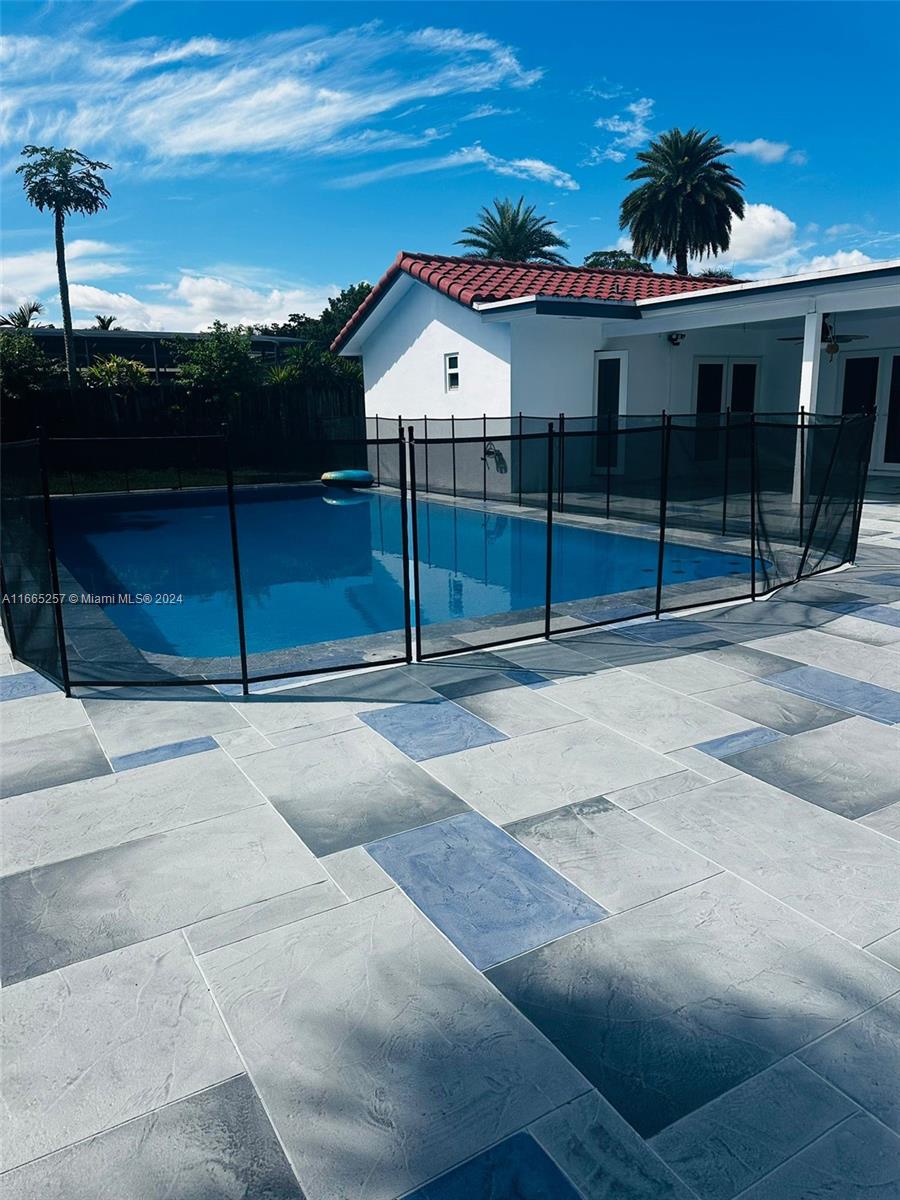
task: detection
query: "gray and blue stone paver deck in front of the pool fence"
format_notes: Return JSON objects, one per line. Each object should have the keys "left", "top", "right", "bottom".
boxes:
{"left": 0, "top": 488, "right": 900, "bottom": 1200}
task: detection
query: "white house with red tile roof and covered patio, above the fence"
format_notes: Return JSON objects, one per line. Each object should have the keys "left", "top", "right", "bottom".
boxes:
{"left": 332, "top": 252, "right": 900, "bottom": 474}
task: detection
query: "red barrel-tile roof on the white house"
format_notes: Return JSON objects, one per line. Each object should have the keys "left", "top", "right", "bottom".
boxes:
{"left": 331, "top": 250, "right": 737, "bottom": 350}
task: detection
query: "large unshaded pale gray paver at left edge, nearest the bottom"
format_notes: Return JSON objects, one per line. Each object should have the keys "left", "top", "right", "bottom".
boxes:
{"left": 2, "top": 934, "right": 241, "bottom": 1168}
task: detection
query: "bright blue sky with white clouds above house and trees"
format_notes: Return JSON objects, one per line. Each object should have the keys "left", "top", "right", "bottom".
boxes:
{"left": 0, "top": 0, "right": 900, "bottom": 329}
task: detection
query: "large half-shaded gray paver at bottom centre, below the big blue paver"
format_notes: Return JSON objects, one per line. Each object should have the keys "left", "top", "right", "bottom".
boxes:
{"left": 200, "top": 889, "right": 587, "bottom": 1200}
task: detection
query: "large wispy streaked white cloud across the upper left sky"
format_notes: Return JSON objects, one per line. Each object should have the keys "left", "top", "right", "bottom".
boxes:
{"left": 2, "top": 22, "right": 541, "bottom": 168}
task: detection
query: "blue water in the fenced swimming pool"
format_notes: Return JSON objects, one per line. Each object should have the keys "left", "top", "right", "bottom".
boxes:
{"left": 55, "top": 487, "right": 749, "bottom": 658}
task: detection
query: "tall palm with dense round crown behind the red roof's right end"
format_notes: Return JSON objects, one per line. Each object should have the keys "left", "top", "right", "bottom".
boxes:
{"left": 619, "top": 130, "right": 744, "bottom": 275}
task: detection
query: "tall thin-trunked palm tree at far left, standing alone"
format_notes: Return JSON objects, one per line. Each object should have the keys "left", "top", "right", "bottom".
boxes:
{"left": 16, "top": 145, "right": 110, "bottom": 390}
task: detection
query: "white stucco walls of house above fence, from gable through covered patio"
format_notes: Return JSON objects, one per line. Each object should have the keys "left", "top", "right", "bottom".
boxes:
{"left": 362, "top": 281, "right": 900, "bottom": 458}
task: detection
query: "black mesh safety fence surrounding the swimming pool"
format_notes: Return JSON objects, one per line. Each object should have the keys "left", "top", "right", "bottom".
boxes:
{"left": 0, "top": 412, "right": 875, "bottom": 691}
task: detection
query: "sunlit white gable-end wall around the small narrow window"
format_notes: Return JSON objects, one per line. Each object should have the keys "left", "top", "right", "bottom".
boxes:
{"left": 362, "top": 282, "right": 510, "bottom": 418}
